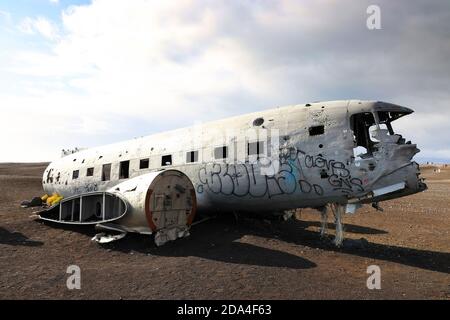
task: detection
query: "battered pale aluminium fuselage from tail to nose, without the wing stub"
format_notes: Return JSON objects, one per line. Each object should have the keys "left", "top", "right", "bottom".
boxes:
{"left": 39, "top": 100, "right": 426, "bottom": 245}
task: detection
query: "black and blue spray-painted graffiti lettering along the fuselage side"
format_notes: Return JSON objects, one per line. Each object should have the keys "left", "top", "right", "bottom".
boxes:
{"left": 197, "top": 147, "right": 364, "bottom": 198}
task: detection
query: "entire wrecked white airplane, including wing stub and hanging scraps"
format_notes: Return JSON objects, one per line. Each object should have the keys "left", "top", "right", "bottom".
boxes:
{"left": 26, "top": 100, "right": 427, "bottom": 246}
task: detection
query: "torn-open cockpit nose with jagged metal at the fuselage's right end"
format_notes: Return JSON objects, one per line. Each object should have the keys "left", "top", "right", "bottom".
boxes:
{"left": 349, "top": 102, "right": 426, "bottom": 207}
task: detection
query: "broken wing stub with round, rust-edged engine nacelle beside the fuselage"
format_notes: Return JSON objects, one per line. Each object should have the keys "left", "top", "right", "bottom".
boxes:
{"left": 36, "top": 170, "right": 197, "bottom": 246}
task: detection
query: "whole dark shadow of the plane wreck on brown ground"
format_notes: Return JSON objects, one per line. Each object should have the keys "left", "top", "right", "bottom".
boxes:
{"left": 36, "top": 215, "right": 450, "bottom": 273}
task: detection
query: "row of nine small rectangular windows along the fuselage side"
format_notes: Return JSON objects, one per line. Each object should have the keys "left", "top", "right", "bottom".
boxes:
{"left": 72, "top": 141, "right": 270, "bottom": 181}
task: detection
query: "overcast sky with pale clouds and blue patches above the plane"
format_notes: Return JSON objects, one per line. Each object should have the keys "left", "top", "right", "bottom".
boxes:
{"left": 0, "top": 0, "right": 450, "bottom": 162}
